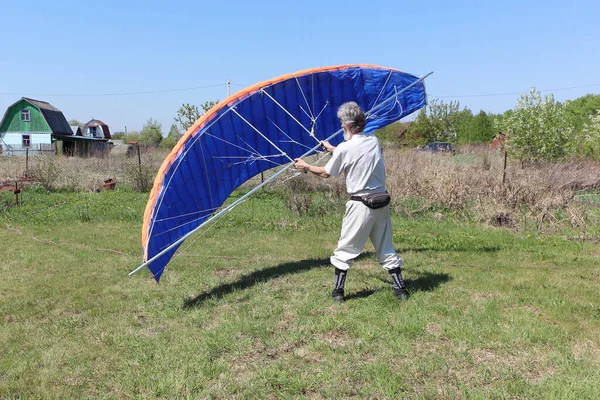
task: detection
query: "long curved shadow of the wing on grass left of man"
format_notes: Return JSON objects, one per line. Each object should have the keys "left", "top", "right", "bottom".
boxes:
{"left": 183, "top": 258, "right": 331, "bottom": 308}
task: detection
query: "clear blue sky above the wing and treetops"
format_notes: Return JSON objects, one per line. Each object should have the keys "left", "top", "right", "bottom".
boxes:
{"left": 0, "top": 0, "right": 600, "bottom": 133}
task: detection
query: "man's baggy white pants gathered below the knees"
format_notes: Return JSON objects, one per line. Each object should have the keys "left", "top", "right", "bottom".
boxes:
{"left": 331, "top": 200, "right": 402, "bottom": 271}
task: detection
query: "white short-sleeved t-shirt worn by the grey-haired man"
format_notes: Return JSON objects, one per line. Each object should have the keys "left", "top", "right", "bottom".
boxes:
{"left": 325, "top": 133, "right": 386, "bottom": 196}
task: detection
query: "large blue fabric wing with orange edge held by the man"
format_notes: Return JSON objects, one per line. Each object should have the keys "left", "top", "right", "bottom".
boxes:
{"left": 142, "top": 65, "right": 426, "bottom": 281}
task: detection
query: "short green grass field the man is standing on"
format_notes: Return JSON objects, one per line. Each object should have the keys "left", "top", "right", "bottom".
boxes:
{"left": 0, "top": 188, "right": 600, "bottom": 399}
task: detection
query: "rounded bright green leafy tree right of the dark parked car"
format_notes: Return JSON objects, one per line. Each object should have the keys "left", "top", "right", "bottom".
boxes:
{"left": 500, "top": 88, "right": 574, "bottom": 161}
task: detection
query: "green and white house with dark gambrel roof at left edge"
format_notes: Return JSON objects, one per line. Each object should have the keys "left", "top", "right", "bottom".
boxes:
{"left": 0, "top": 97, "right": 73, "bottom": 155}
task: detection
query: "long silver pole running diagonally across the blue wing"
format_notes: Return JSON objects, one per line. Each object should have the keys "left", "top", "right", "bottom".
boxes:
{"left": 129, "top": 72, "right": 433, "bottom": 276}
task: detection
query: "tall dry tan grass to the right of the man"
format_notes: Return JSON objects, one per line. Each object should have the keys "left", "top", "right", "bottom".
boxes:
{"left": 385, "top": 149, "right": 600, "bottom": 231}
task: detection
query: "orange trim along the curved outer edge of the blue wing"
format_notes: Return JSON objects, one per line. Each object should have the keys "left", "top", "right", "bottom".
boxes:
{"left": 142, "top": 64, "right": 399, "bottom": 261}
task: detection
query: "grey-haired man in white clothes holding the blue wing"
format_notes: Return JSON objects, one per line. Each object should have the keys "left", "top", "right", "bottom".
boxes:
{"left": 294, "top": 102, "right": 408, "bottom": 302}
